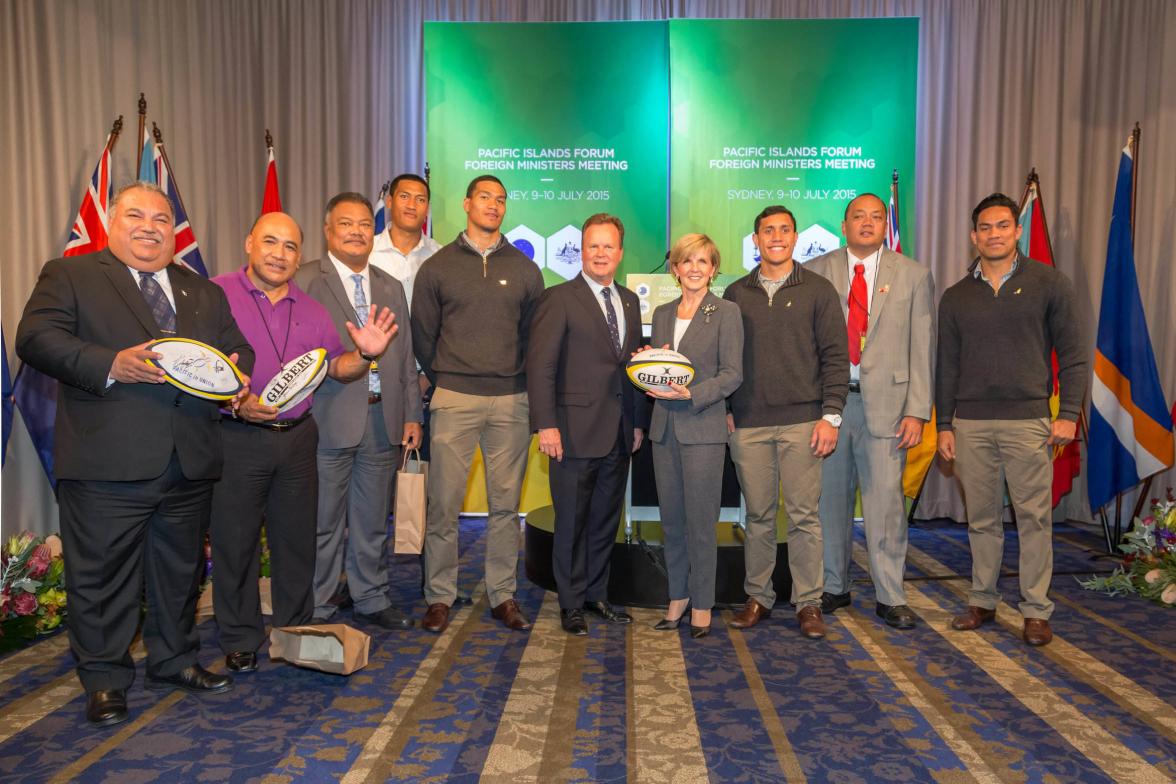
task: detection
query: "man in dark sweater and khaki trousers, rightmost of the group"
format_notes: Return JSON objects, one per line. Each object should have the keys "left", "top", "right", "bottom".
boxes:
{"left": 935, "top": 193, "right": 1089, "bottom": 645}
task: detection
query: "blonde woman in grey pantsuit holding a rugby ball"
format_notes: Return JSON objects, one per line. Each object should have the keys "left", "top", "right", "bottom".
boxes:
{"left": 649, "top": 234, "right": 743, "bottom": 637}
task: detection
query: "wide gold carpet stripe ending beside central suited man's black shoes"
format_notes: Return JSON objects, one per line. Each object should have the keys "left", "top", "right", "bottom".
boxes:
{"left": 480, "top": 591, "right": 566, "bottom": 784}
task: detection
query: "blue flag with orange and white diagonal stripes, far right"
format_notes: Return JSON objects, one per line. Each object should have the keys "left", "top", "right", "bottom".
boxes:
{"left": 1087, "top": 141, "right": 1174, "bottom": 510}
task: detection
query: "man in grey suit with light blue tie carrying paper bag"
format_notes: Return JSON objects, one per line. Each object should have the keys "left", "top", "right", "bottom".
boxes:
{"left": 295, "top": 193, "right": 421, "bottom": 629}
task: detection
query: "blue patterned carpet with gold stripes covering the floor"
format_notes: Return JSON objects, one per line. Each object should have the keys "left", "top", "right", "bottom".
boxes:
{"left": 0, "top": 518, "right": 1176, "bottom": 784}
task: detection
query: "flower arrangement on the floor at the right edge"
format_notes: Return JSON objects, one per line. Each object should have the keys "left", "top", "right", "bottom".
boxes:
{"left": 1078, "top": 488, "right": 1176, "bottom": 607}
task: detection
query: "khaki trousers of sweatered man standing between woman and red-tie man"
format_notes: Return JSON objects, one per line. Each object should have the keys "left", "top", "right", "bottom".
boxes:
{"left": 729, "top": 422, "right": 840, "bottom": 610}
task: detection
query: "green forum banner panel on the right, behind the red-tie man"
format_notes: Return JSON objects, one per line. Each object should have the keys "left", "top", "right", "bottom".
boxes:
{"left": 669, "top": 19, "right": 918, "bottom": 273}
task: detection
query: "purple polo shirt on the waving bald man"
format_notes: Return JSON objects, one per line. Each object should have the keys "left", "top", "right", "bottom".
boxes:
{"left": 213, "top": 267, "right": 347, "bottom": 421}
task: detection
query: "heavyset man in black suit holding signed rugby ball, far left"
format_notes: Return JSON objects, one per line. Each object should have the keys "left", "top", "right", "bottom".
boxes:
{"left": 16, "top": 183, "right": 254, "bottom": 725}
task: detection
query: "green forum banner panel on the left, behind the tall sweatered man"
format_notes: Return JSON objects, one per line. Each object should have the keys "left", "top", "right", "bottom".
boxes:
{"left": 425, "top": 21, "right": 669, "bottom": 286}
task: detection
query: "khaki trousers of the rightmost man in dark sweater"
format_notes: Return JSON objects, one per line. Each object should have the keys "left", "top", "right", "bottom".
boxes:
{"left": 953, "top": 417, "right": 1054, "bottom": 618}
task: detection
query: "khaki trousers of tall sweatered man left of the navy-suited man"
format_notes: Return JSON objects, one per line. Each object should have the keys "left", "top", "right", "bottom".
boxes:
{"left": 425, "top": 388, "right": 530, "bottom": 607}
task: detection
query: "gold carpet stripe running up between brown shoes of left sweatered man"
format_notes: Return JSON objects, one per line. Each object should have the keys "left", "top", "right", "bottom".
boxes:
{"left": 342, "top": 594, "right": 487, "bottom": 784}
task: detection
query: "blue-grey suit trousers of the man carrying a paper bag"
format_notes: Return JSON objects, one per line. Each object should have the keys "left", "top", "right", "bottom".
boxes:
{"left": 314, "top": 403, "right": 400, "bottom": 618}
